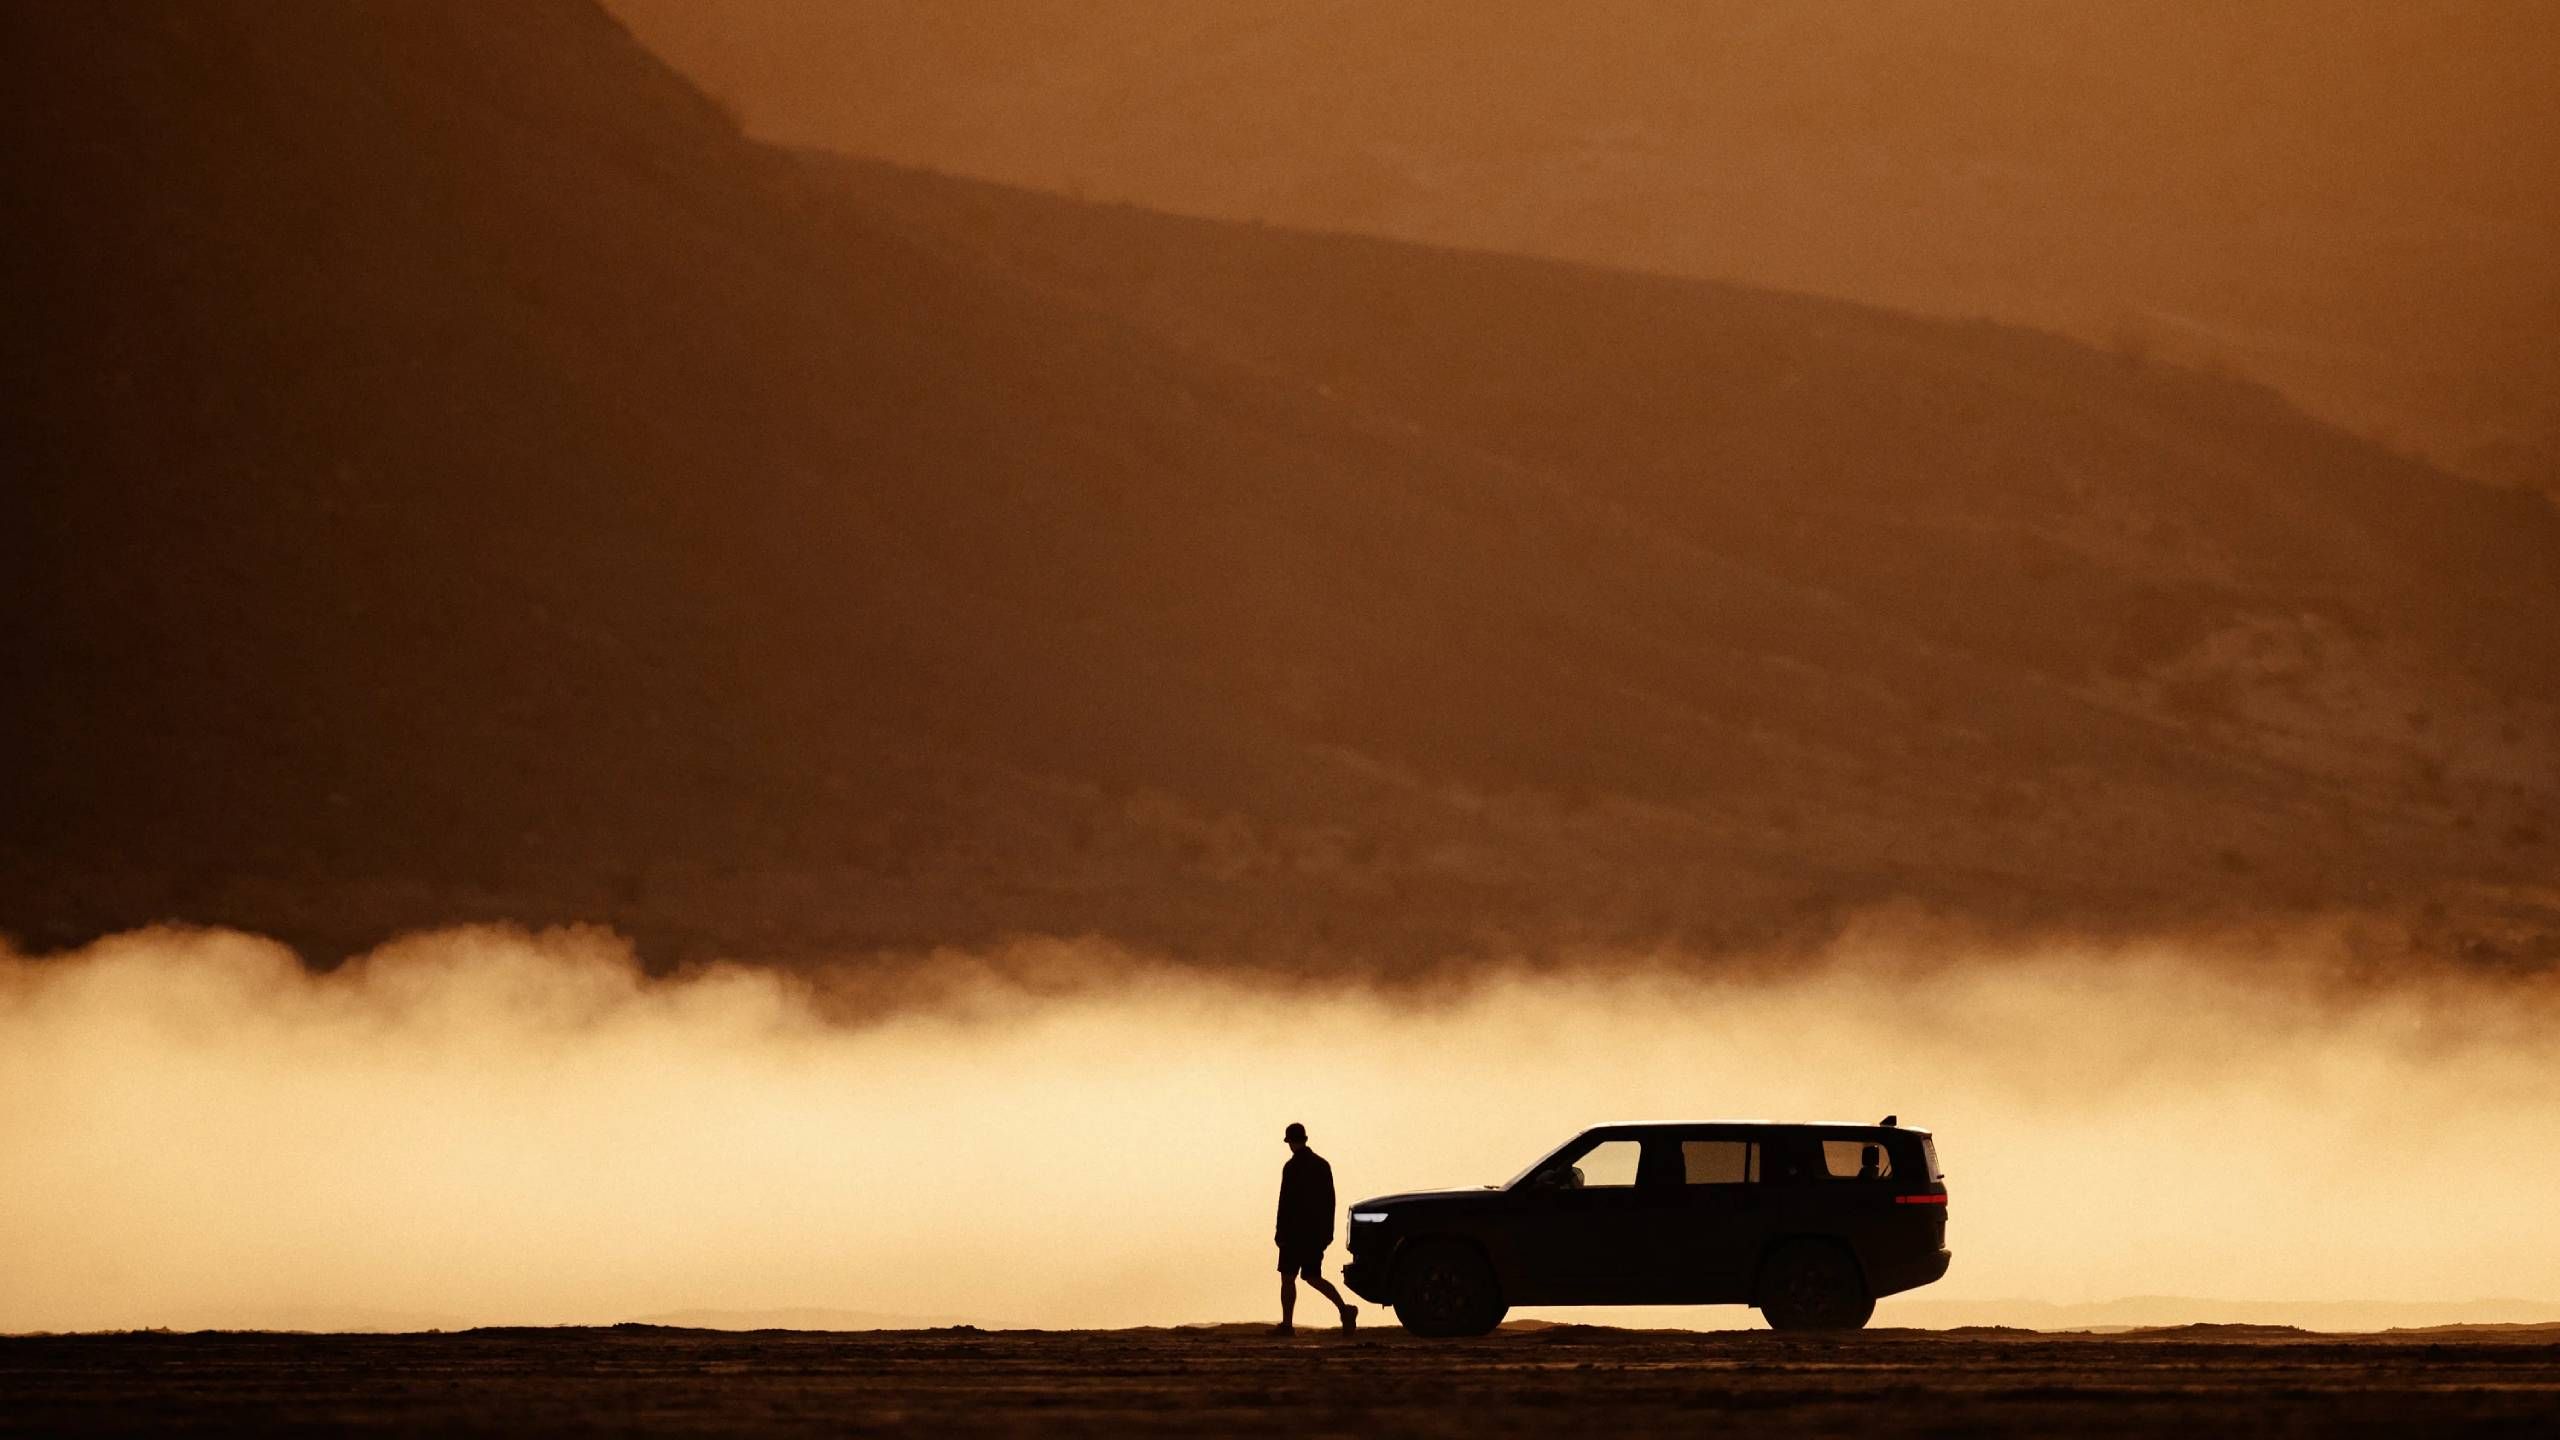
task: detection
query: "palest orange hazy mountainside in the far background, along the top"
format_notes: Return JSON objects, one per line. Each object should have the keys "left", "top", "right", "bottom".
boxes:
{"left": 612, "top": 0, "right": 2560, "bottom": 487}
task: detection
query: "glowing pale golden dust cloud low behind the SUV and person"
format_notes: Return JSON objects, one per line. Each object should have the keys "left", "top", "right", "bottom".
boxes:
{"left": 0, "top": 928, "right": 2560, "bottom": 1330}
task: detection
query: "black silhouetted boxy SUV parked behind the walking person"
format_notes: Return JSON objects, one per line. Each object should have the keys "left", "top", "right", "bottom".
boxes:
{"left": 1341, "top": 1115, "right": 1948, "bottom": 1335}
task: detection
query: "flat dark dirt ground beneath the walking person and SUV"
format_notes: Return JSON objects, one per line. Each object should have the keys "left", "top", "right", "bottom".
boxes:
{"left": 0, "top": 1325, "right": 2560, "bottom": 1435}
